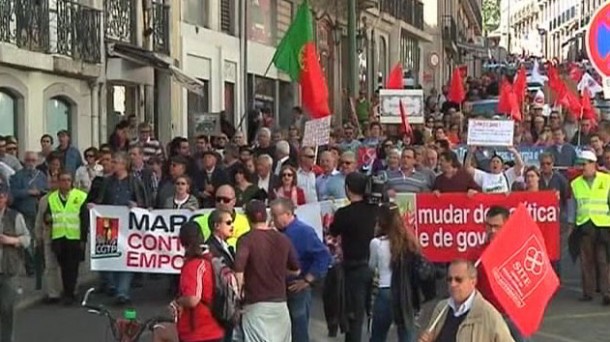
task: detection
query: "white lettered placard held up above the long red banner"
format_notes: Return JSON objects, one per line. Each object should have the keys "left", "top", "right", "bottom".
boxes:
{"left": 467, "top": 119, "right": 515, "bottom": 146}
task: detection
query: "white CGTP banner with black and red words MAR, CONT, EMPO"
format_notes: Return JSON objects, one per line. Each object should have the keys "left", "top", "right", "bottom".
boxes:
{"left": 89, "top": 202, "right": 324, "bottom": 273}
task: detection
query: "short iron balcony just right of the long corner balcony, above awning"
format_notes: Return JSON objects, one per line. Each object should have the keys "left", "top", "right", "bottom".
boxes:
{"left": 104, "top": 0, "right": 137, "bottom": 45}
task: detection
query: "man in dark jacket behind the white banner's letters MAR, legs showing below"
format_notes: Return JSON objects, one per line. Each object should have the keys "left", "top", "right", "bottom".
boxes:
{"left": 94, "top": 152, "right": 148, "bottom": 305}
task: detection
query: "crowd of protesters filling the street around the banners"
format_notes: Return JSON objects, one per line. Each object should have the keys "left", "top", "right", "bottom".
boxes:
{"left": 0, "top": 57, "right": 610, "bottom": 342}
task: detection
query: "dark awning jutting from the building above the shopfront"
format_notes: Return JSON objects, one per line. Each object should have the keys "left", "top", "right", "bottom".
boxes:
{"left": 108, "top": 43, "right": 204, "bottom": 96}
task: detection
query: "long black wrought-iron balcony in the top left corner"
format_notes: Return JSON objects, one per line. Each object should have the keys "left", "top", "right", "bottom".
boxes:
{"left": 0, "top": 0, "right": 101, "bottom": 64}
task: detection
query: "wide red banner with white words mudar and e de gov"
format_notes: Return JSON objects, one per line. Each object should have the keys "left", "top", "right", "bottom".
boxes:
{"left": 395, "top": 191, "right": 560, "bottom": 262}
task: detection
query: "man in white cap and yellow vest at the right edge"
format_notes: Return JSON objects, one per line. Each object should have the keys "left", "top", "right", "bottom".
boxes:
{"left": 568, "top": 150, "right": 610, "bottom": 305}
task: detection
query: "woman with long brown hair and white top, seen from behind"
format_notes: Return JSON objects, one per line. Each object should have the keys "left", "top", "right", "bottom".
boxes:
{"left": 369, "top": 203, "right": 421, "bottom": 342}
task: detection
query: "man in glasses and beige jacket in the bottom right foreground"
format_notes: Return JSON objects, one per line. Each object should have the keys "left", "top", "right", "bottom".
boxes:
{"left": 419, "top": 260, "right": 513, "bottom": 342}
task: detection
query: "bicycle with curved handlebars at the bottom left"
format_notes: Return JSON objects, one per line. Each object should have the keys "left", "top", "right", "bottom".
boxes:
{"left": 81, "top": 288, "right": 176, "bottom": 342}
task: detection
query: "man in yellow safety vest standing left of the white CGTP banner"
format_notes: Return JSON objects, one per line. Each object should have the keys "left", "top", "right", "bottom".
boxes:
{"left": 46, "top": 172, "right": 87, "bottom": 305}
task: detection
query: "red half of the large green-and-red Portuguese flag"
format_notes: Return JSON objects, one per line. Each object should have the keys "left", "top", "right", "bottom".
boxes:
{"left": 301, "top": 44, "right": 330, "bottom": 119}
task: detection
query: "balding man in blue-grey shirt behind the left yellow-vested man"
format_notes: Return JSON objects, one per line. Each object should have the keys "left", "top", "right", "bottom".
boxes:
{"left": 10, "top": 151, "right": 49, "bottom": 275}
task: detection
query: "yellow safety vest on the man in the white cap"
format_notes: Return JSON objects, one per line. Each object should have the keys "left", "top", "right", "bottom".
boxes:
{"left": 571, "top": 172, "right": 610, "bottom": 228}
